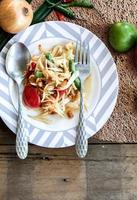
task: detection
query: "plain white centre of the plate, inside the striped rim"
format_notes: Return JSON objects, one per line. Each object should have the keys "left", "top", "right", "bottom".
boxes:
{"left": 9, "top": 38, "right": 101, "bottom": 131}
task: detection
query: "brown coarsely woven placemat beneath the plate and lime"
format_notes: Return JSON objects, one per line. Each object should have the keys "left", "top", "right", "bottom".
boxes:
{"left": 32, "top": 0, "right": 137, "bottom": 143}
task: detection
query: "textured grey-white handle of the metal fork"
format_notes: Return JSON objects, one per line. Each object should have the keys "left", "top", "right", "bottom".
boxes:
{"left": 75, "top": 89, "right": 88, "bottom": 158}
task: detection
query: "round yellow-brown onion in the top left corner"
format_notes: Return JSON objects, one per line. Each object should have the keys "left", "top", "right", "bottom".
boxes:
{"left": 0, "top": 0, "right": 33, "bottom": 33}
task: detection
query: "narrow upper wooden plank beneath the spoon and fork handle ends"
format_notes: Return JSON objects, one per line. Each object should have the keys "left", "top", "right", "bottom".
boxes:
{"left": 0, "top": 144, "right": 137, "bottom": 161}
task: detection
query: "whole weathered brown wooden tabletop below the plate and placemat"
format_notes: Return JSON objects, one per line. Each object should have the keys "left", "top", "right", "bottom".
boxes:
{"left": 0, "top": 144, "right": 137, "bottom": 200}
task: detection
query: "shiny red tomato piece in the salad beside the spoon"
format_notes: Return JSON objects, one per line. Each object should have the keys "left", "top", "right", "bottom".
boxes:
{"left": 23, "top": 85, "right": 40, "bottom": 108}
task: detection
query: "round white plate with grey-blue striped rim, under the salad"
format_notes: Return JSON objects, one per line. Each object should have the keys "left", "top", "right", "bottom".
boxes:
{"left": 0, "top": 22, "right": 118, "bottom": 147}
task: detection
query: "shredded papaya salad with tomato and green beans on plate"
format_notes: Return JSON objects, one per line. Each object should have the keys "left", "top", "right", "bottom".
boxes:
{"left": 23, "top": 42, "right": 84, "bottom": 122}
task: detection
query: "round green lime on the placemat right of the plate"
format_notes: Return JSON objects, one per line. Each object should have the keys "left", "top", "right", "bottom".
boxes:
{"left": 109, "top": 22, "right": 137, "bottom": 52}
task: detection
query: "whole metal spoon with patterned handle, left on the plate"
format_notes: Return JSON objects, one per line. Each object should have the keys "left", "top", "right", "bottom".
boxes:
{"left": 6, "top": 42, "right": 31, "bottom": 159}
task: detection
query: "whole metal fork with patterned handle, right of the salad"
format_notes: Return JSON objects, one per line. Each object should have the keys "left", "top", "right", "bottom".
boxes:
{"left": 74, "top": 43, "right": 90, "bottom": 158}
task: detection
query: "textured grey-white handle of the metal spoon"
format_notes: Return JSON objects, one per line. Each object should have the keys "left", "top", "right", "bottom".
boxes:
{"left": 16, "top": 99, "right": 29, "bottom": 159}
